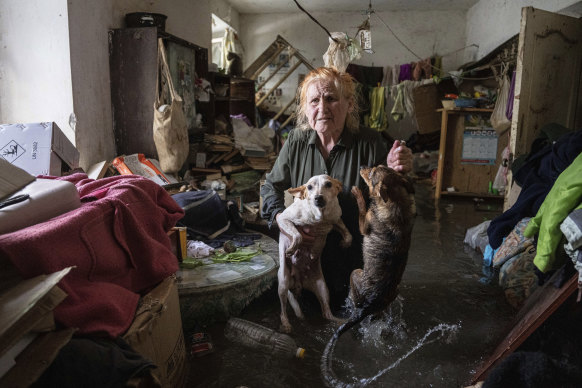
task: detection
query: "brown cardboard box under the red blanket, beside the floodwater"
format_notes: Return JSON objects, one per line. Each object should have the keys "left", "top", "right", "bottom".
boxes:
{"left": 123, "top": 277, "right": 186, "bottom": 388}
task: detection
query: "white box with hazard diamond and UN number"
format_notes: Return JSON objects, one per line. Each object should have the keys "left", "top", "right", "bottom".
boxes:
{"left": 0, "top": 122, "right": 79, "bottom": 176}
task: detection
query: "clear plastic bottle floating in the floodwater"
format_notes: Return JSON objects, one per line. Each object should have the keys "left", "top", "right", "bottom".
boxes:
{"left": 224, "top": 318, "right": 305, "bottom": 358}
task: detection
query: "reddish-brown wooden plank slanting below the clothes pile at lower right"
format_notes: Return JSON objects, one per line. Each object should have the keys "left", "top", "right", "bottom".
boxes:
{"left": 472, "top": 271, "right": 578, "bottom": 384}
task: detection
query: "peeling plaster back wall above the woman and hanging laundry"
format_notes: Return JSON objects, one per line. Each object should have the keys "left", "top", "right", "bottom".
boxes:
{"left": 239, "top": 10, "right": 466, "bottom": 139}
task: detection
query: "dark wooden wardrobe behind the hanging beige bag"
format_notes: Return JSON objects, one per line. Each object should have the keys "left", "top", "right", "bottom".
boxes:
{"left": 109, "top": 27, "right": 214, "bottom": 159}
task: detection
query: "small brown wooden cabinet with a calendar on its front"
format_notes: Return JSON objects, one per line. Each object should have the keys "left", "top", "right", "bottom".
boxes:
{"left": 435, "top": 108, "right": 508, "bottom": 199}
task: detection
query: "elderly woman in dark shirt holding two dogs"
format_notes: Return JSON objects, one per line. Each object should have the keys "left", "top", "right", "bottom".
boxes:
{"left": 261, "top": 67, "right": 412, "bottom": 306}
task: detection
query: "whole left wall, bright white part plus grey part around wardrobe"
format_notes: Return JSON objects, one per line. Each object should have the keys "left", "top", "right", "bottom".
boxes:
{"left": 0, "top": 0, "right": 219, "bottom": 168}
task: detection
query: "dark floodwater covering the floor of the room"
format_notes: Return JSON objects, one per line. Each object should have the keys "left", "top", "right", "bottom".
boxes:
{"left": 186, "top": 183, "right": 515, "bottom": 388}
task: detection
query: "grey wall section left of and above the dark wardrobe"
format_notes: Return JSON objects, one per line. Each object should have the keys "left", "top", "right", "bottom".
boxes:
{"left": 69, "top": 0, "right": 211, "bottom": 168}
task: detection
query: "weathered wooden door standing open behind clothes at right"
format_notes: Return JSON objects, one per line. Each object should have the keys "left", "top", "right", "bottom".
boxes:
{"left": 504, "top": 7, "right": 582, "bottom": 209}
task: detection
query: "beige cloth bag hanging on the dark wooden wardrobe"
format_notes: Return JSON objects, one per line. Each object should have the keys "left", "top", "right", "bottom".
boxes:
{"left": 154, "top": 39, "right": 190, "bottom": 173}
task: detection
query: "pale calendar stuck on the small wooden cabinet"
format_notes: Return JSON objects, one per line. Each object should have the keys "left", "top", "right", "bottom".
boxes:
{"left": 461, "top": 126, "right": 499, "bottom": 165}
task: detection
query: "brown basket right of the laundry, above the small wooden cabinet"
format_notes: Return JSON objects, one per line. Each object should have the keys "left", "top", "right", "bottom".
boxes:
{"left": 412, "top": 84, "right": 442, "bottom": 134}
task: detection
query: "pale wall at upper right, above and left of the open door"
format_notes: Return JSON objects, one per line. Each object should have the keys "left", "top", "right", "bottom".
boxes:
{"left": 466, "top": 0, "right": 580, "bottom": 60}
